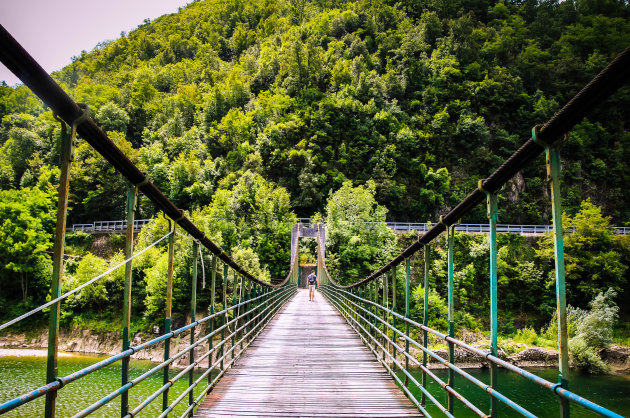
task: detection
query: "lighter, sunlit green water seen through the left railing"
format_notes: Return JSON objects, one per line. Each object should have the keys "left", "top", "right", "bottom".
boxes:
{"left": 0, "top": 355, "right": 205, "bottom": 418}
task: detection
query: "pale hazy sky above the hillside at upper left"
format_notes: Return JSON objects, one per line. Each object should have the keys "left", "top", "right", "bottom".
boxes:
{"left": 0, "top": 0, "right": 192, "bottom": 86}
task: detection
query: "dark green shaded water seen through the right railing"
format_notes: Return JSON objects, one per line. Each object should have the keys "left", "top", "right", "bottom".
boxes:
{"left": 401, "top": 367, "right": 630, "bottom": 418}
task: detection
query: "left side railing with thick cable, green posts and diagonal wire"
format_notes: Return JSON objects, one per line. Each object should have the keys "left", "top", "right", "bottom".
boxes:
{"left": 0, "top": 26, "right": 298, "bottom": 418}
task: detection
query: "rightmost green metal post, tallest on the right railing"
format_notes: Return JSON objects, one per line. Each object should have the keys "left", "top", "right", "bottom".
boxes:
{"left": 545, "top": 146, "right": 569, "bottom": 417}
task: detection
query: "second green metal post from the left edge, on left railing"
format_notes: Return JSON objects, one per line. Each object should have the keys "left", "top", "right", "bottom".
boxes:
{"left": 120, "top": 186, "right": 138, "bottom": 417}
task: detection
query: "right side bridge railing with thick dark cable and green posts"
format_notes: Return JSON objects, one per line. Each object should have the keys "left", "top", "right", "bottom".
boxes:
{"left": 318, "top": 47, "right": 630, "bottom": 417}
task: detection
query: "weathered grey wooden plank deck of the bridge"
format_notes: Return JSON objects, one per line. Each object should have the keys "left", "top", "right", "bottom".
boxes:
{"left": 195, "top": 290, "right": 420, "bottom": 417}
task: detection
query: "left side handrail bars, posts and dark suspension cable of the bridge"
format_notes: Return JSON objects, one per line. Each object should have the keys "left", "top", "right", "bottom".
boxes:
{"left": 0, "top": 25, "right": 297, "bottom": 417}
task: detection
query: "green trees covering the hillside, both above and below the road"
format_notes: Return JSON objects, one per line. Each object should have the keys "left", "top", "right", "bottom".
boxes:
{"left": 0, "top": 0, "right": 630, "bottom": 346}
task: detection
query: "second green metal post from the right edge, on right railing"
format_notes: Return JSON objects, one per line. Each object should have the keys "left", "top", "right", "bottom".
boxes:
{"left": 486, "top": 185, "right": 499, "bottom": 417}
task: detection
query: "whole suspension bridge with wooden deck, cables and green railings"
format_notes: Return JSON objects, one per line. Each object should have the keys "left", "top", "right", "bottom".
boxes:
{"left": 0, "top": 26, "right": 630, "bottom": 417}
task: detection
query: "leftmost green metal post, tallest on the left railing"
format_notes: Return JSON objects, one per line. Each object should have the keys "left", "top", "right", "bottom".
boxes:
{"left": 44, "top": 115, "right": 76, "bottom": 418}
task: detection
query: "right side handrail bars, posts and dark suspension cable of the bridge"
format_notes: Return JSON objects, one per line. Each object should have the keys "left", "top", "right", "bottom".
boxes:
{"left": 318, "top": 47, "right": 630, "bottom": 418}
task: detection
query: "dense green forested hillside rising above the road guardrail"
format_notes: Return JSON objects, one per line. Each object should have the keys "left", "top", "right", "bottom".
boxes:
{"left": 0, "top": 0, "right": 630, "bottom": 223}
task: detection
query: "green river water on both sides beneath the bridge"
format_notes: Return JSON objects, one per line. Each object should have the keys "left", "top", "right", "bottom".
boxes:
{"left": 0, "top": 355, "right": 630, "bottom": 418}
